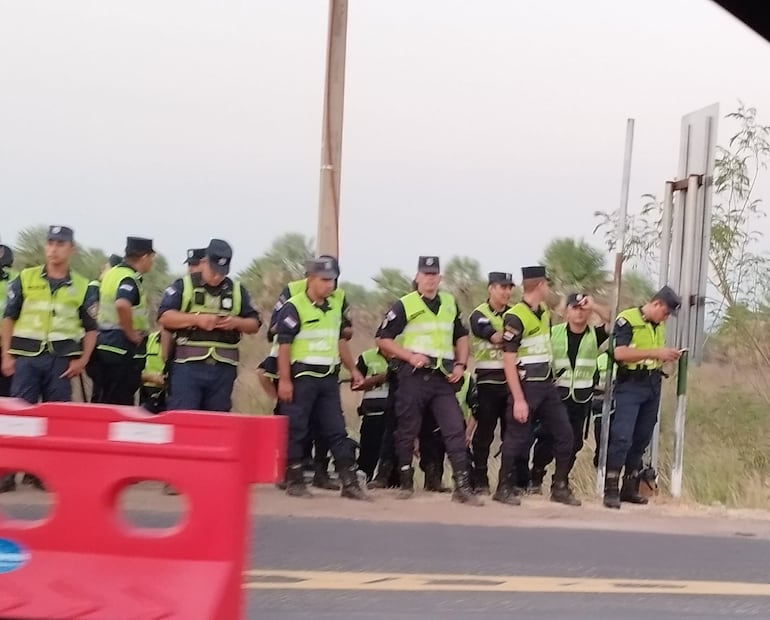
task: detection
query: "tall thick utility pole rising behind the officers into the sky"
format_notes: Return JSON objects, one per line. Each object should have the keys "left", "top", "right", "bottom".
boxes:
{"left": 316, "top": 0, "right": 348, "bottom": 257}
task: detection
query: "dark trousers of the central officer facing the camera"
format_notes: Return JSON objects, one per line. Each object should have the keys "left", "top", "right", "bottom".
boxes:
{"left": 395, "top": 364, "right": 469, "bottom": 474}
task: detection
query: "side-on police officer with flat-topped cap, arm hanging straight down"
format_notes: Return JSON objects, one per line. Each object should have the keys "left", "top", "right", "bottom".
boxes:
{"left": 493, "top": 265, "right": 580, "bottom": 506}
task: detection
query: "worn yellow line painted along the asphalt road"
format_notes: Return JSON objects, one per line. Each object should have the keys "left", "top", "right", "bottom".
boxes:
{"left": 243, "top": 569, "right": 770, "bottom": 597}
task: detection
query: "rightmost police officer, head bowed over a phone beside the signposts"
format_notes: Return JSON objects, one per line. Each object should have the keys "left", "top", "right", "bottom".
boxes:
{"left": 604, "top": 286, "right": 682, "bottom": 508}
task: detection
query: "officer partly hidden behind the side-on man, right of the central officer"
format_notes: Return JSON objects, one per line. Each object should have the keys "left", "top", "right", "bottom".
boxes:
{"left": 470, "top": 271, "right": 513, "bottom": 495}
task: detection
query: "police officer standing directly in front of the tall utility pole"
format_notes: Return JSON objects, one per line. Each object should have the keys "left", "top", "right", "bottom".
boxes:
{"left": 276, "top": 259, "right": 366, "bottom": 499}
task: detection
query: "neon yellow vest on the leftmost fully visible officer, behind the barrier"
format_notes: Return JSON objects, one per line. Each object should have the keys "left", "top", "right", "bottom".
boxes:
{"left": 10, "top": 267, "right": 88, "bottom": 356}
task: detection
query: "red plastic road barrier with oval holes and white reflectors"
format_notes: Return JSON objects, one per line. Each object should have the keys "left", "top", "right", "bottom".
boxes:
{"left": 0, "top": 399, "right": 286, "bottom": 620}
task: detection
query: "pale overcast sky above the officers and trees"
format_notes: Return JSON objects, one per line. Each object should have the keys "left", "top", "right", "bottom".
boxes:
{"left": 0, "top": 0, "right": 770, "bottom": 283}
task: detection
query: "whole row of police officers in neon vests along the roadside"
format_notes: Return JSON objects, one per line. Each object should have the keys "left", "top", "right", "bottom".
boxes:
{"left": 0, "top": 226, "right": 681, "bottom": 508}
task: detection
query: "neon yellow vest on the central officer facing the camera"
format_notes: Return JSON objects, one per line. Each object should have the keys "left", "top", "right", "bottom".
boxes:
{"left": 401, "top": 291, "right": 457, "bottom": 373}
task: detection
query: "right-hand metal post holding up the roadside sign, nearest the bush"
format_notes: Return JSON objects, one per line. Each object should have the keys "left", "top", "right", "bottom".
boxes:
{"left": 671, "top": 174, "right": 700, "bottom": 497}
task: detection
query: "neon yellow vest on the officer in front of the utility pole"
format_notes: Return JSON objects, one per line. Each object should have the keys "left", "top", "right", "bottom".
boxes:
{"left": 286, "top": 291, "right": 342, "bottom": 377}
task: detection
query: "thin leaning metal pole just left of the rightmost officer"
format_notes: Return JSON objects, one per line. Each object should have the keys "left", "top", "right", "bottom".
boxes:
{"left": 596, "top": 118, "right": 634, "bottom": 495}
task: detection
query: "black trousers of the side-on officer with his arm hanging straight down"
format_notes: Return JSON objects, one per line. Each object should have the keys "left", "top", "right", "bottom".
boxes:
{"left": 503, "top": 381, "right": 573, "bottom": 486}
